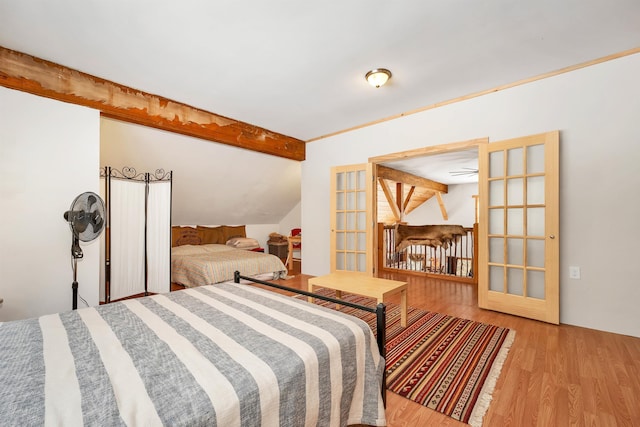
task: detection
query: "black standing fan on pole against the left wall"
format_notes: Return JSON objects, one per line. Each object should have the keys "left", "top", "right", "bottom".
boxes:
{"left": 64, "top": 191, "right": 104, "bottom": 310}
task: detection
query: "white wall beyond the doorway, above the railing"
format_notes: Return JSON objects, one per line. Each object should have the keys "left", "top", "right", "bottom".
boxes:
{"left": 405, "top": 183, "right": 478, "bottom": 227}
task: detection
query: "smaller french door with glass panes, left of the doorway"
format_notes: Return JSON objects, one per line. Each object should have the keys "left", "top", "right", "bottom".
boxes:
{"left": 331, "top": 163, "right": 373, "bottom": 275}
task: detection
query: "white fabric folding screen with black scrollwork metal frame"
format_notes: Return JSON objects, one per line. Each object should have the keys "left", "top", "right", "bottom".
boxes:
{"left": 100, "top": 166, "right": 172, "bottom": 302}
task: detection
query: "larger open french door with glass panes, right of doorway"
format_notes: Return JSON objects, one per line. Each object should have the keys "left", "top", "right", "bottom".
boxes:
{"left": 478, "top": 131, "right": 560, "bottom": 324}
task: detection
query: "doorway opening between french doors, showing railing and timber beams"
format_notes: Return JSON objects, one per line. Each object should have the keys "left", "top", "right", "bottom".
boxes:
{"left": 369, "top": 138, "right": 488, "bottom": 283}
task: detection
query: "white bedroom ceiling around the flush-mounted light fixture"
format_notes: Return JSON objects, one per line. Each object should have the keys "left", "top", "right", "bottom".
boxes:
{"left": 0, "top": 0, "right": 640, "bottom": 145}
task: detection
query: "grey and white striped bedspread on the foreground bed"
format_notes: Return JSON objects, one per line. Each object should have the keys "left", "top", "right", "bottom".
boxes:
{"left": 0, "top": 283, "right": 385, "bottom": 427}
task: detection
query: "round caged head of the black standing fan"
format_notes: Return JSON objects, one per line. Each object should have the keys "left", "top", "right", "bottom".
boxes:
{"left": 64, "top": 191, "right": 104, "bottom": 242}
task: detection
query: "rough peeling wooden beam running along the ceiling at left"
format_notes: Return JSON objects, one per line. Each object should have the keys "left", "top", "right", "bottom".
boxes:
{"left": 0, "top": 46, "right": 305, "bottom": 161}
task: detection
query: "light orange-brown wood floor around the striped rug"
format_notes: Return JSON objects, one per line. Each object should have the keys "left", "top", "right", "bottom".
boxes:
{"left": 270, "top": 271, "right": 640, "bottom": 427}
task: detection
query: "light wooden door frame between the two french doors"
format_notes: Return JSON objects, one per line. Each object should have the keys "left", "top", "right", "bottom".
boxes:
{"left": 368, "top": 137, "right": 489, "bottom": 275}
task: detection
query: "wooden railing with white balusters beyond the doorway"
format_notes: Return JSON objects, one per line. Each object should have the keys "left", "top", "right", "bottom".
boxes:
{"left": 378, "top": 224, "right": 478, "bottom": 283}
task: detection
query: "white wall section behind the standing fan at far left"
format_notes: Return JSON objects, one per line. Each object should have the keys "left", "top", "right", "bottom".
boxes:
{"left": 0, "top": 87, "right": 100, "bottom": 321}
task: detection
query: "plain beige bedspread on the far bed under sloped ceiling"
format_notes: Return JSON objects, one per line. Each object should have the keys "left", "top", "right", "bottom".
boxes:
{"left": 171, "top": 244, "right": 287, "bottom": 288}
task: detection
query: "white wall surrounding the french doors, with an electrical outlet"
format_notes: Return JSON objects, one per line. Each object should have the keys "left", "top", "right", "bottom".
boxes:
{"left": 302, "top": 54, "right": 640, "bottom": 337}
